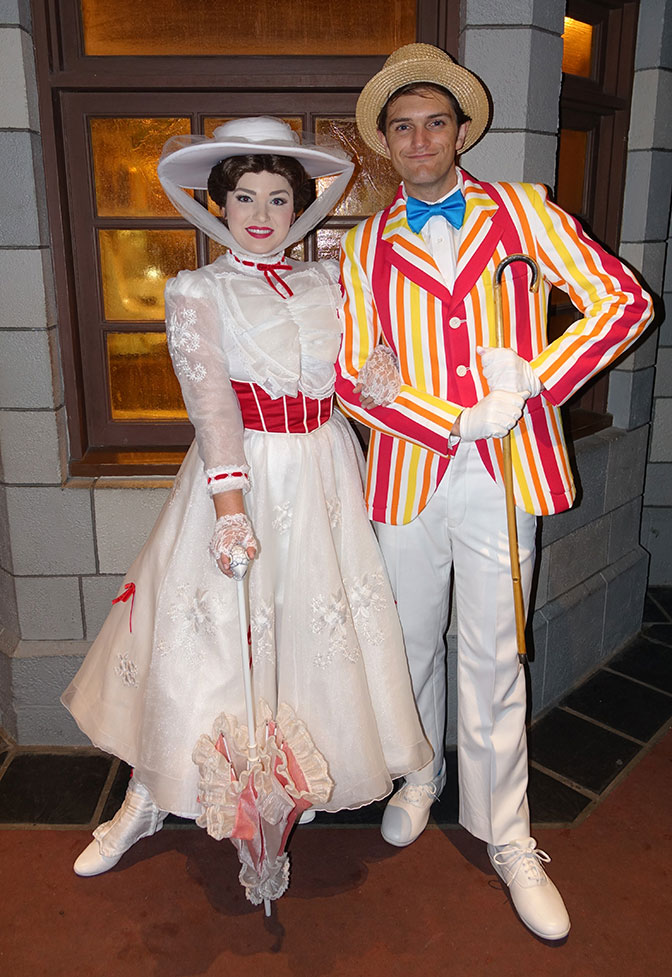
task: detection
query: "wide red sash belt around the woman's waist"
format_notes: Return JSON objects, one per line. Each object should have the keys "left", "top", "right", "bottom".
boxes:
{"left": 231, "top": 380, "right": 334, "bottom": 434}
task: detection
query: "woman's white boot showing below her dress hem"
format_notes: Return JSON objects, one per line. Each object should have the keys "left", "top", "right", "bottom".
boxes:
{"left": 73, "top": 777, "right": 168, "bottom": 876}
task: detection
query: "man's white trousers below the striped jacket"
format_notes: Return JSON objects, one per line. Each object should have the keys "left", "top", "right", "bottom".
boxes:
{"left": 374, "top": 442, "right": 536, "bottom": 845}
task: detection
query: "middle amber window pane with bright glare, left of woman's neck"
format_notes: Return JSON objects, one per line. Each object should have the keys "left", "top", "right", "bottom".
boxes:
{"left": 98, "top": 229, "right": 196, "bottom": 322}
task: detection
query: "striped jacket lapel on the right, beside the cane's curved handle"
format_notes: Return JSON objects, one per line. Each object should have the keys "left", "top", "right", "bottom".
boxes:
{"left": 450, "top": 171, "right": 506, "bottom": 305}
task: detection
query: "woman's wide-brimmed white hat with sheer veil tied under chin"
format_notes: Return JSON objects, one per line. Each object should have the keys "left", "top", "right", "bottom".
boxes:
{"left": 157, "top": 116, "right": 354, "bottom": 260}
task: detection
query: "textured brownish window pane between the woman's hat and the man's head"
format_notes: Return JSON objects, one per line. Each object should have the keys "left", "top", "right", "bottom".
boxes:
{"left": 315, "top": 118, "right": 399, "bottom": 217}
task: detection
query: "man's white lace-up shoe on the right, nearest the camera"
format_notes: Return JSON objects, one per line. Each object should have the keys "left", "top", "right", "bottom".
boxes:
{"left": 488, "top": 838, "right": 570, "bottom": 940}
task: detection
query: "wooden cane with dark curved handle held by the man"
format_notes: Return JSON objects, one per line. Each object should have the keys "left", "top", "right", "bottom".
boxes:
{"left": 493, "top": 254, "right": 539, "bottom": 664}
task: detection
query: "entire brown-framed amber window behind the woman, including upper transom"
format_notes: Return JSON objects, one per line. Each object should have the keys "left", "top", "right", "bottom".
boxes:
{"left": 33, "top": 0, "right": 452, "bottom": 475}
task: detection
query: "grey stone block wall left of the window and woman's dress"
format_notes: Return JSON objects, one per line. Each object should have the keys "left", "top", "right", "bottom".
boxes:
{"left": 0, "top": 0, "right": 170, "bottom": 744}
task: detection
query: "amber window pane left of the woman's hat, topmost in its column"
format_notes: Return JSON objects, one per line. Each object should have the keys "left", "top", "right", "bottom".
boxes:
{"left": 89, "top": 118, "right": 191, "bottom": 217}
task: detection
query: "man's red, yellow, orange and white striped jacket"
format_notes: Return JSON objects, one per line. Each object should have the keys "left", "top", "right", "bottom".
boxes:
{"left": 336, "top": 171, "right": 653, "bottom": 524}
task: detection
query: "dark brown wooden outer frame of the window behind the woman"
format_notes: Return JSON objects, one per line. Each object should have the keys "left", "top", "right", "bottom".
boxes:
{"left": 32, "top": 0, "right": 459, "bottom": 476}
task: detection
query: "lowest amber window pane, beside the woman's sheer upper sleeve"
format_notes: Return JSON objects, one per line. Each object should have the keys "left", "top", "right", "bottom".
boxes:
{"left": 107, "top": 332, "right": 187, "bottom": 421}
